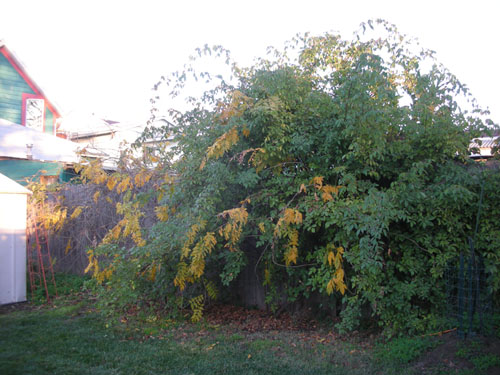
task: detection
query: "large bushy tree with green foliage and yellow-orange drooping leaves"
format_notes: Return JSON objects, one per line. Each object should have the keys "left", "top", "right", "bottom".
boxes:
{"left": 80, "top": 21, "right": 500, "bottom": 332}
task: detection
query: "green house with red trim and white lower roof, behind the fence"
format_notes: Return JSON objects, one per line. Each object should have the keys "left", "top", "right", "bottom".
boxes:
{"left": 0, "top": 40, "right": 79, "bottom": 185}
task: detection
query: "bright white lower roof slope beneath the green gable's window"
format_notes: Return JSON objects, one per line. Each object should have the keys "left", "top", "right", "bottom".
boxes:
{"left": 0, "top": 119, "right": 81, "bottom": 163}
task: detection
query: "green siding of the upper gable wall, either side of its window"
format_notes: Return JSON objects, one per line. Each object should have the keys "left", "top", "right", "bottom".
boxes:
{"left": 0, "top": 54, "right": 54, "bottom": 134}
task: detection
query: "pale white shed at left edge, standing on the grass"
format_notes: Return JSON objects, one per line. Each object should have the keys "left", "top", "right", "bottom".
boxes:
{"left": 0, "top": 173, "right": 31, "bottom": 305}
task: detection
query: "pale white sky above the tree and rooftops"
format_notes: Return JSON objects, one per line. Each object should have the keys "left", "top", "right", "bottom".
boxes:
{"left": 0, "top": 0, "right": 500, "bottom": 128}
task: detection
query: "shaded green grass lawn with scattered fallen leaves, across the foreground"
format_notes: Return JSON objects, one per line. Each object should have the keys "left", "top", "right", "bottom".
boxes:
{"left": 0, "top": 274, "right": 500, "bottom": 375}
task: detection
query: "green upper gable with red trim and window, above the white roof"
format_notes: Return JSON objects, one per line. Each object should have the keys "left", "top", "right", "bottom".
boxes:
{"left": 0, "top": 41, "right": 61, "bottom": 134}
